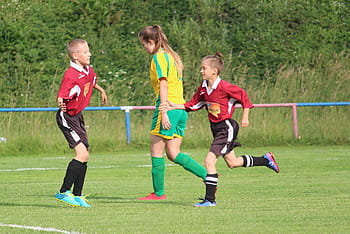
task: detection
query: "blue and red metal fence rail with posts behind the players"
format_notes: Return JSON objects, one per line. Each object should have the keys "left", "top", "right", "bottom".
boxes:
{"left": 0, "top": 102, "right": 350, "bottom": 144}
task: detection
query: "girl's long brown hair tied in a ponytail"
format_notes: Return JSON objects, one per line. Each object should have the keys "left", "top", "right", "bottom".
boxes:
{"left": 138, "top": 25, "right": 184, "bottom": 76}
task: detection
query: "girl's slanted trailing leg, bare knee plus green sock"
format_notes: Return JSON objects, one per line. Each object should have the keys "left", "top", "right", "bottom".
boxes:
{"left": 166, "top": 137, "right": 207, "bottom": 180}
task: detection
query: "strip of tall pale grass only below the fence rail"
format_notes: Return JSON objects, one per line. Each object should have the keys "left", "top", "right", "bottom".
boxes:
{"left": 0, "top": 103, "right": 350, "bottom": 156}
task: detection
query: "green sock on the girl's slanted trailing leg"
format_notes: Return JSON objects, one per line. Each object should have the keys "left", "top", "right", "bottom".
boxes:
{"left": 174, "top": 153, "right": 207, "bottom": 180}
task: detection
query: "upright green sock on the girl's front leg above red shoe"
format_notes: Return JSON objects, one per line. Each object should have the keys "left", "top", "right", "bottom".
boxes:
{"left": 151, "top": 157, "right": 165, "bottom": 196}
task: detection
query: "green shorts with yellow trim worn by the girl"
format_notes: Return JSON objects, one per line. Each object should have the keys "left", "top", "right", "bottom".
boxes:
{"left": 151, "top": 108, "right": 188, "bottom": 139}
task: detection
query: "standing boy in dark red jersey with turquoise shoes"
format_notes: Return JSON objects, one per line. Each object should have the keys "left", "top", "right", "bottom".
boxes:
{"left": 55, "top": 39, "right": 107, "bottom": 207}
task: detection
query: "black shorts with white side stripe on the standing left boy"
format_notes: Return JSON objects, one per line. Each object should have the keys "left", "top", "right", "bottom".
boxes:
{"left": 56, "top": 110, "right": 89, "bottom": 148}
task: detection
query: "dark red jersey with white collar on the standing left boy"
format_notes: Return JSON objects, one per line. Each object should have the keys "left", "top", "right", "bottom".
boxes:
{"left": 57, "top": 61, "right": 96, "bottom": 116}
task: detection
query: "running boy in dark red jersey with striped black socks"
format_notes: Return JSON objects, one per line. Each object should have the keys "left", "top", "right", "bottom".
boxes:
{"left": 161, "top": 52, "right": 279, "bottom": 207}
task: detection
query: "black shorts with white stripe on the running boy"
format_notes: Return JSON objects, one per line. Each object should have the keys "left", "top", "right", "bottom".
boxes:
{"left": 209, "top": 119, "right": 241, "bottom": 156}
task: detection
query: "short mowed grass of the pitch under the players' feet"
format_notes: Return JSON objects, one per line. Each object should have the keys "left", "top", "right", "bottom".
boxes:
{"left": 0, "top": 146, "right": 350, "bottom": 233}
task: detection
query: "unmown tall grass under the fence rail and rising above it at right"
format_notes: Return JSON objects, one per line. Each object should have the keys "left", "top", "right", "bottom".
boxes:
{"left": 0, "top": 54, "right": 350, "bottom": 155}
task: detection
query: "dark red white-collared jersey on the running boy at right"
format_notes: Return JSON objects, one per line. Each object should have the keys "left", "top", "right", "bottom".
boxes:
{"left": 185, "top": 77, "right": 254, "bottom": 123}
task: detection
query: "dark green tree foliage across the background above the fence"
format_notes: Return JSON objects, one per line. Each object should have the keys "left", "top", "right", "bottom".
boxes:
{"left": 0, "top": 0, "right": 350, "bottom": 107}
